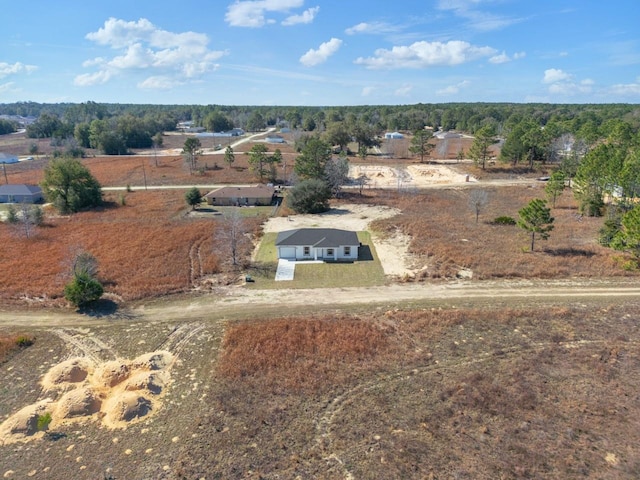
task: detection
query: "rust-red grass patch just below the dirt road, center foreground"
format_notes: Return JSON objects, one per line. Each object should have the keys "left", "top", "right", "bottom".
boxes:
{"left": 218, "top": 317, "right": 390, "bottom": 391}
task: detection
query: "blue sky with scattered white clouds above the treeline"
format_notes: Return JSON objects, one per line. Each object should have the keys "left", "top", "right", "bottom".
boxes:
{"left": 0, "top": 0, "right": 640, "bottom": 106}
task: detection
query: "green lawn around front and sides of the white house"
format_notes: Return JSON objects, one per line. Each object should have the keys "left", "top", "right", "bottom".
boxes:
{"left": 248, "top": 232, "right": 386, "bottom": 289}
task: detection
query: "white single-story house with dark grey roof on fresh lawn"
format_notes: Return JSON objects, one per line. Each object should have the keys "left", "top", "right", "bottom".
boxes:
{"left": 276, "top": 228, "right": 360, "bottom": 261}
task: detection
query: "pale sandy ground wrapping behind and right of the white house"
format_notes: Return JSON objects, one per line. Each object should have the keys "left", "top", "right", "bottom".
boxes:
{"left": 264, "top": 204, "right": 415, "bottom": 276}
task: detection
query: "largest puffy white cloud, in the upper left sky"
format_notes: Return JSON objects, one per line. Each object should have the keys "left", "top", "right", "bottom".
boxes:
{"left": 74, "top": 18, "right": 227, "bottom": 88}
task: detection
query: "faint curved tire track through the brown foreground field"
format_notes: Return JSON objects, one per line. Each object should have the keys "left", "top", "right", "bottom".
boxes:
{"left": 309, "top": 340, "right": 640, "bottom": 479}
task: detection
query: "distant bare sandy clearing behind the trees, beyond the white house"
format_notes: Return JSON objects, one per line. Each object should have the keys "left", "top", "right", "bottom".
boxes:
{"left": 349, "top": 164, "right": 477, "bottom": 188}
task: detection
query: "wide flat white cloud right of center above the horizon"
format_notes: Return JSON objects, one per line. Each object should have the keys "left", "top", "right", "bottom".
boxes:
{"left": 355, "top": 40, "right": 496, "bottom": 69}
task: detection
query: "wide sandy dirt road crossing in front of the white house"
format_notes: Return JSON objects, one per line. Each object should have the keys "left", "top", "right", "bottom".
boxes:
{"left": 0, "top": 279, "right": 640, "bottom": 328}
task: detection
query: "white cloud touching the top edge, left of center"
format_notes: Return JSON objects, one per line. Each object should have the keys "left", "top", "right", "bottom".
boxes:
{"left": 224, "top": 0, "right": 320, "bottom": 28}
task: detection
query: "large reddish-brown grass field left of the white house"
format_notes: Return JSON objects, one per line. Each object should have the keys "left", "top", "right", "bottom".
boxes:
{"left": 0, "top": 190, "right": 260, "bottom": 300}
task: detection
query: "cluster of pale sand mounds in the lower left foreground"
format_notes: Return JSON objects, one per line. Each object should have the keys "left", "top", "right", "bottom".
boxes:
{"left": 0, "top": 351, "right": 174, "bottom": 445}
